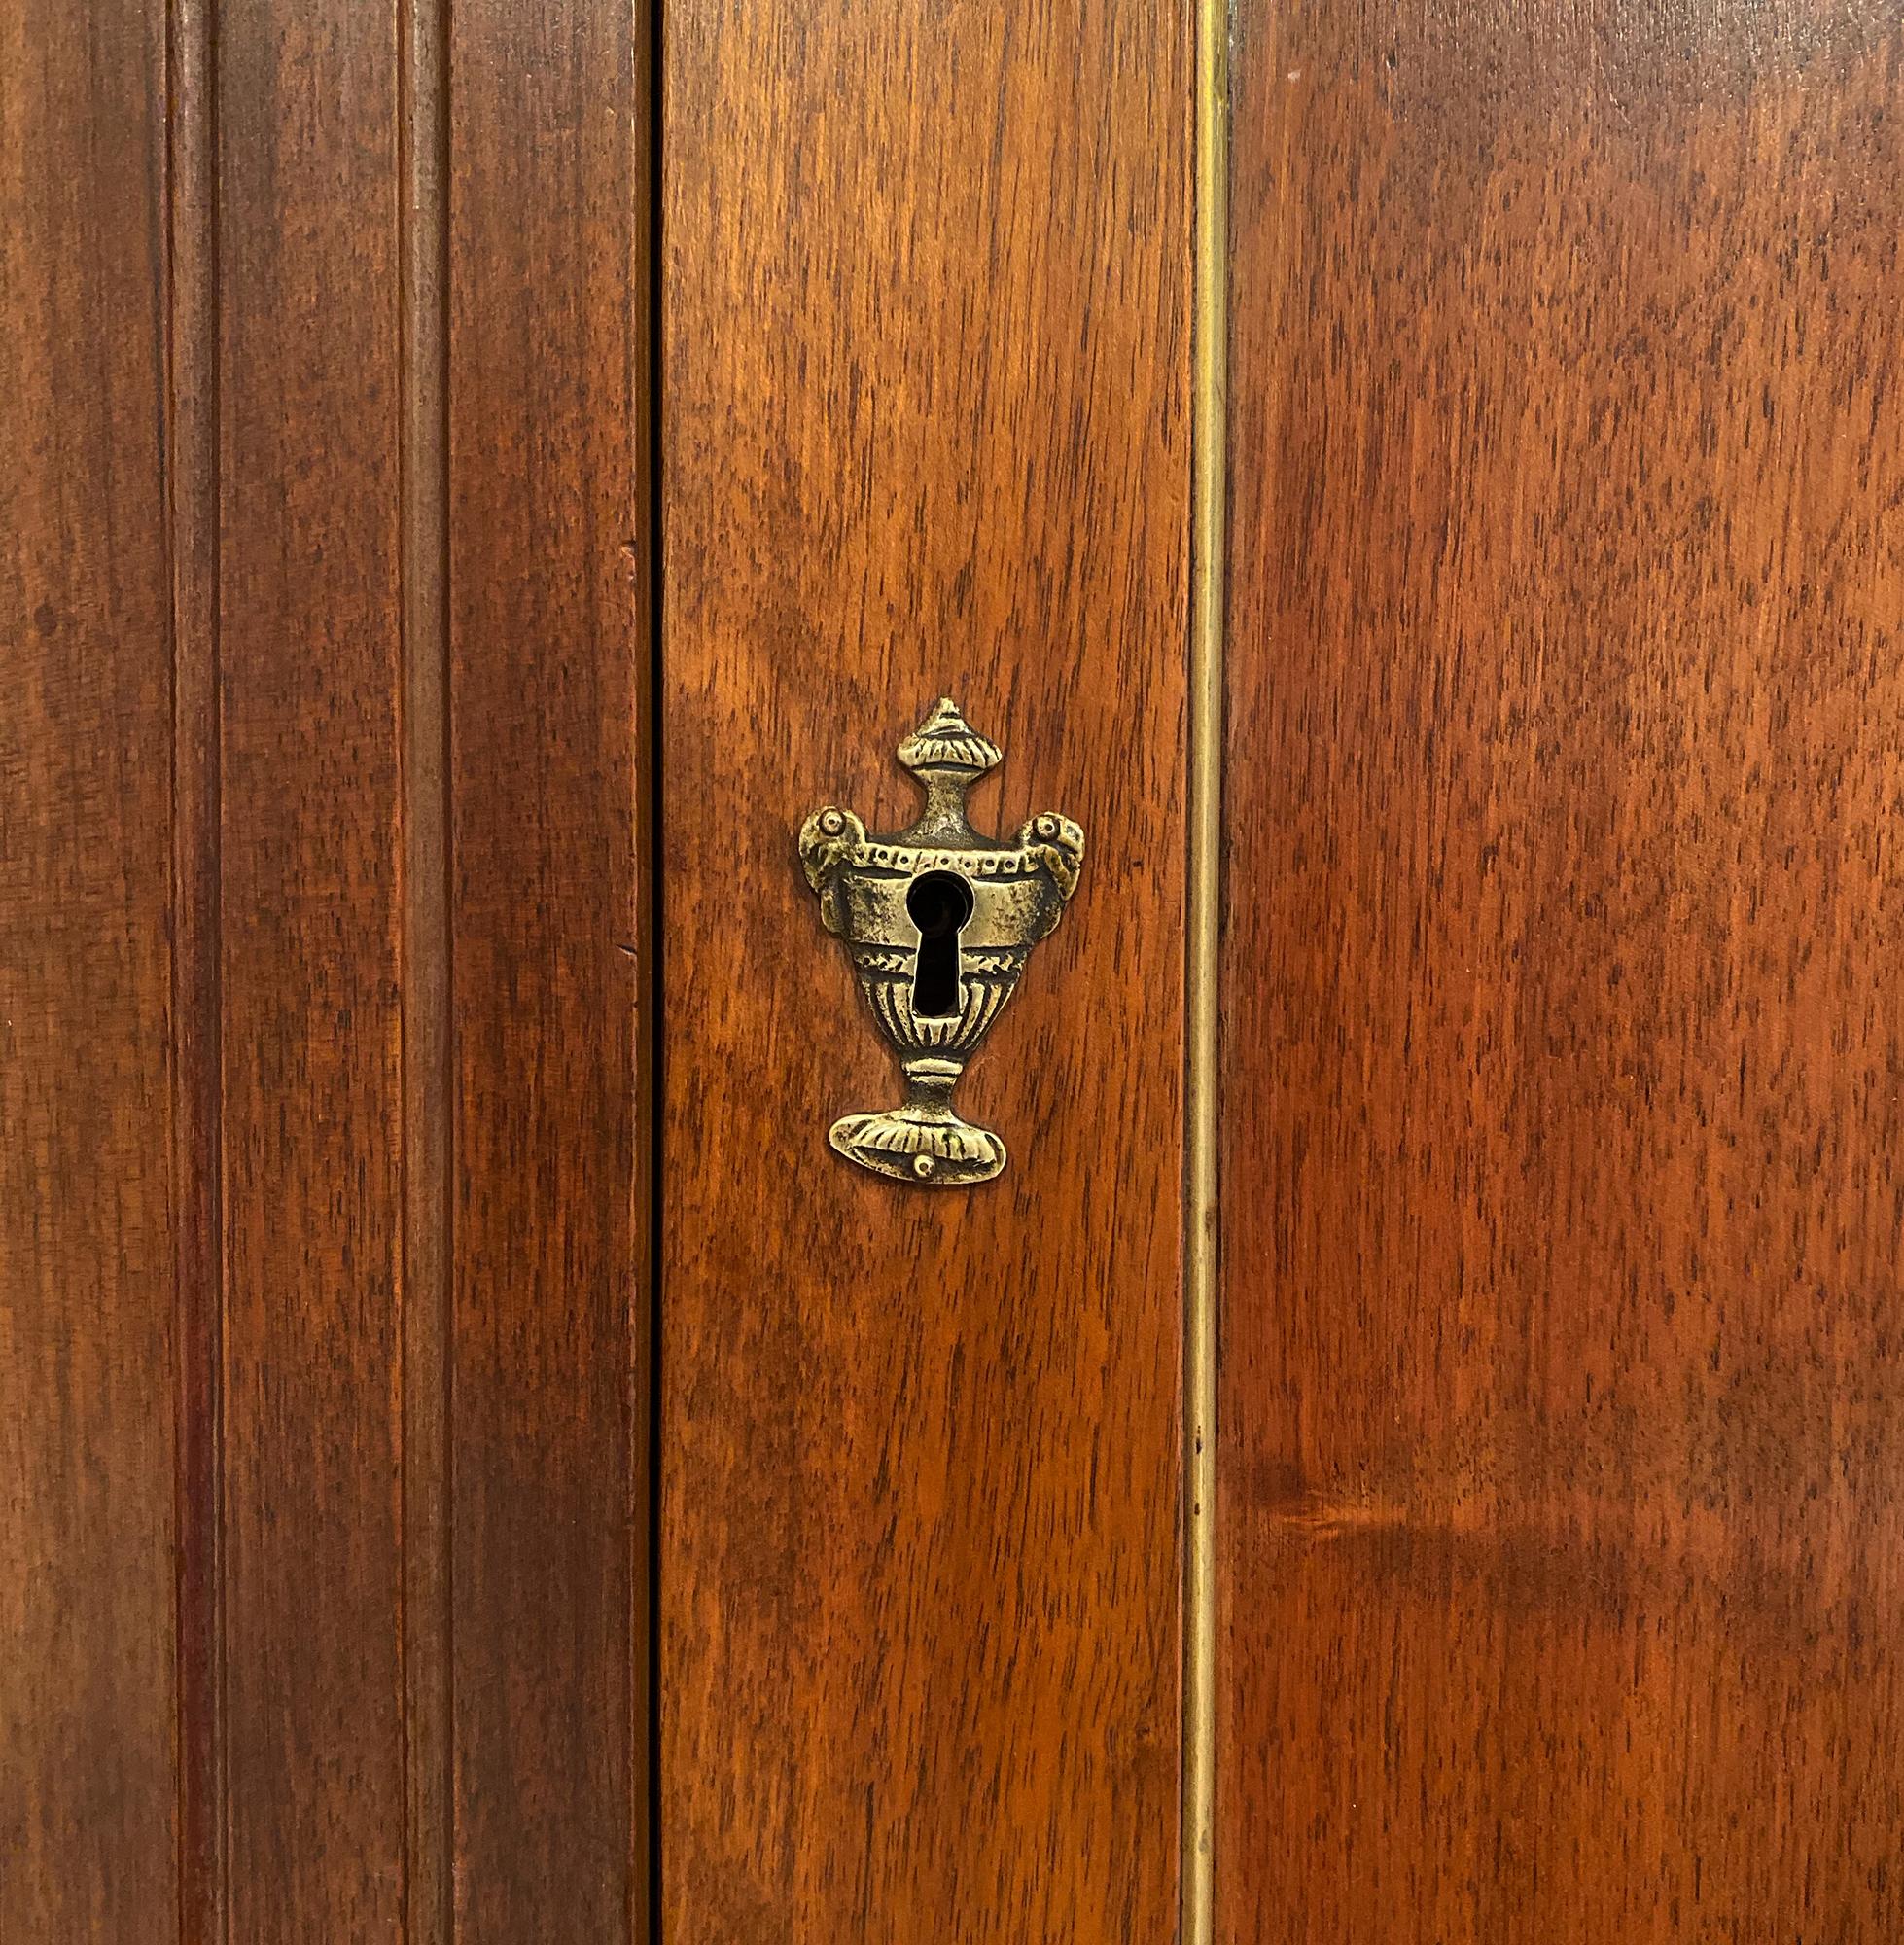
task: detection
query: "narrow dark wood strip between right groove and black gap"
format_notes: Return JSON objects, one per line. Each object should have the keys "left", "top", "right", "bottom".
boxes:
{"left": 449, "top": 0, "right": 652, "bottom": 1945}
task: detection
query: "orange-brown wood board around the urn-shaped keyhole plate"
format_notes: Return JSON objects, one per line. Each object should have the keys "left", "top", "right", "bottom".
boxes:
{"left": 661, "top": 0, "right": 1188, "bottom": 1941}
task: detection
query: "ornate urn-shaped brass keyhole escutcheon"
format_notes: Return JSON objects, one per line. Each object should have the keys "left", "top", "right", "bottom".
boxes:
{"left": 799, "top": 696, "right": 1083, "bottom": 1186}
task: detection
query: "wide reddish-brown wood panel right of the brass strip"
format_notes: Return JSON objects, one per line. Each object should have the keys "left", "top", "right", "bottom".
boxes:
{"left": 1217, "top": 0, "right": 1904, "bottom": 1945}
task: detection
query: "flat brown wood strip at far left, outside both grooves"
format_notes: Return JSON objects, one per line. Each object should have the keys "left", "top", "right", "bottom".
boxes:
{"left": 0, "top": 4, "right": 177, "bottom": 1941}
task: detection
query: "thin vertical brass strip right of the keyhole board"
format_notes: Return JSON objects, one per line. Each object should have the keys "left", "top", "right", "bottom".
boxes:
{"left": 1182, "top": 0, "right": 1229, "bottom": 1945}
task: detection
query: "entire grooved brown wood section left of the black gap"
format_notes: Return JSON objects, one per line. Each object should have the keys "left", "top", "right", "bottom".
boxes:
{"left": 0, "top": 0, "right": 652, "bottom": 1945}
